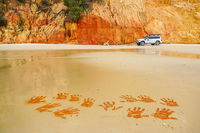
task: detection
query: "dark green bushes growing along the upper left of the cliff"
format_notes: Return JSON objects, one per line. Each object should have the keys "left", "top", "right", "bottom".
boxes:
{"left": 0, "top": 0, "right": 103, "bottom": 26}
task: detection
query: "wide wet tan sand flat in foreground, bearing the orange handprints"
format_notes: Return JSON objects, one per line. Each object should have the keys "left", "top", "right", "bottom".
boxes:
{"left": 0, "top": 49, "right": 200, "bottom": 133}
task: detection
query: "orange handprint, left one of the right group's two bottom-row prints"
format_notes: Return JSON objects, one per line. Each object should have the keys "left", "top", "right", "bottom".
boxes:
{"left": 127, "top": 107, "right": 148, "bottom": 119}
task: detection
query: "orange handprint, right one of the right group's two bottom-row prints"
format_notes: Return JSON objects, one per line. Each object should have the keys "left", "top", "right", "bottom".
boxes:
{"left": 153, "top": 108, "right": 177, "bottom": 120}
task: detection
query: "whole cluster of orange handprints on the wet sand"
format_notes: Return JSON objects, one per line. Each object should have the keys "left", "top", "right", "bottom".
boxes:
{"left": 27, "top": 93, "right": 179, "bottom": 120}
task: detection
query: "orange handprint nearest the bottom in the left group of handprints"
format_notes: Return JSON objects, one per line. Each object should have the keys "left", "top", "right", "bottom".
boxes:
{"left": 53, "top": 107, "right": 80, "bottom": 119}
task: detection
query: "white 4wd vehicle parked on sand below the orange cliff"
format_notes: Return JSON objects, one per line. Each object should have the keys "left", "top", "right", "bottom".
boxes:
{"left": 136, "top": 34, "right": 162, "bottom": 46}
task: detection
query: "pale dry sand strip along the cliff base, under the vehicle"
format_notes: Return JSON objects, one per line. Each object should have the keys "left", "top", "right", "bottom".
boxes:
{"left": 0, "top": 44, "right": 200, "bottom": 54}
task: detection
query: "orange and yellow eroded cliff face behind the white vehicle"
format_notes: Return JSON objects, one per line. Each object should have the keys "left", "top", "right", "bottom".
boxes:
{"left": 0, "top": 0, "right": 200, "bottom": 44}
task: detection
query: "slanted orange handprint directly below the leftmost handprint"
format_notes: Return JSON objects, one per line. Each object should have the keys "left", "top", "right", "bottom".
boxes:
{"left": 36, "top": 103, "right": 61, "bottom": 112}
